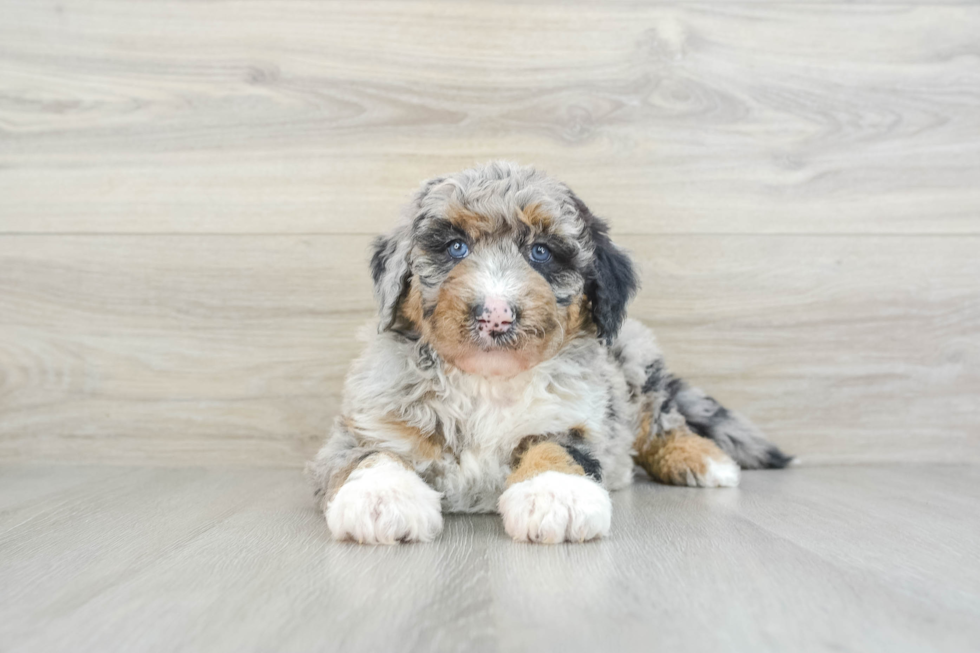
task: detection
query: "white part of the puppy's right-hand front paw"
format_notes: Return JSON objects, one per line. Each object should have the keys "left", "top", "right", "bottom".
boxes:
{"left": 497, "top": 472, "right": 612, "bottom": 544}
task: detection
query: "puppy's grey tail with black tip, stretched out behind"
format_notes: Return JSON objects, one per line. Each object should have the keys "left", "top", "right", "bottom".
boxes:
{"left": 665, "top": 377, "right": 793, "bottom": 469}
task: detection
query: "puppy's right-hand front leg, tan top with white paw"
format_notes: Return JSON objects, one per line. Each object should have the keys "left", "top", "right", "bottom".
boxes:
{"left": 497, "top": 442, "right": 612, "bottom": 544}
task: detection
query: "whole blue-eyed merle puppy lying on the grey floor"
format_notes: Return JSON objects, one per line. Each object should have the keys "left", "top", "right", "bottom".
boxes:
{"left": 309, "top": 162, "right": 790, "bottom": 544}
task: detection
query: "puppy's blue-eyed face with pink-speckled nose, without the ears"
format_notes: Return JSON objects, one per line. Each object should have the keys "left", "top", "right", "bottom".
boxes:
{"left": 402, "top": 204, "right": 592, "bottom": 376}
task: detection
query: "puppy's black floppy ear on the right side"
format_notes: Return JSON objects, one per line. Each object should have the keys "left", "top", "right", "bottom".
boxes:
{"left": 573, "top": 197, "right": 637, "bottom": 343}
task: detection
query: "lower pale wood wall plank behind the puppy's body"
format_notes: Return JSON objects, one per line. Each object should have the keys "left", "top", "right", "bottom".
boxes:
{"left": 0, "top": 235, "right": 980, "bottom": 465}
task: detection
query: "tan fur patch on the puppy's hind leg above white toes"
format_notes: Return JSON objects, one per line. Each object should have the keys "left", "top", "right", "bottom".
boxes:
{"left": 634, "top": 425, "right": 727, "bottom": 485}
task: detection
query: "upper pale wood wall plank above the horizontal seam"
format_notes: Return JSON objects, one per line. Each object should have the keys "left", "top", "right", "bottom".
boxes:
{"left": 0, "top": 0, "right": 980, "bottom": 234}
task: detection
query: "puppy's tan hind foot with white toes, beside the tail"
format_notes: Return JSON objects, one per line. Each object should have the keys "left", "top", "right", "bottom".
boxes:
{"left": 634, "top": 427, "right": 739, "bottom": 487}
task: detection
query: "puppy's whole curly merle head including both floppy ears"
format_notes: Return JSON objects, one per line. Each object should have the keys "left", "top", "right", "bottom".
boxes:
{"left": 371, "top": 162, "right": 636, "bottom": 376}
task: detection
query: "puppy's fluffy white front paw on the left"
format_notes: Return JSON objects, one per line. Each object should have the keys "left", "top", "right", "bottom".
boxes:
{"left": 326, "top": 458, "right": 442, "bottom": 544}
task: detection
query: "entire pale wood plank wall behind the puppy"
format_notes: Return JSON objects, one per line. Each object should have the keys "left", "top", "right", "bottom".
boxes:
{"left": 0, "top": 0, "right": 980, "bottom": 465}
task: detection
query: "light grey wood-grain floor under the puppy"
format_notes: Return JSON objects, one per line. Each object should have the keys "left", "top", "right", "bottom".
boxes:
{"left": 0, "top": 465, "right": 980, "bottom": 653}
